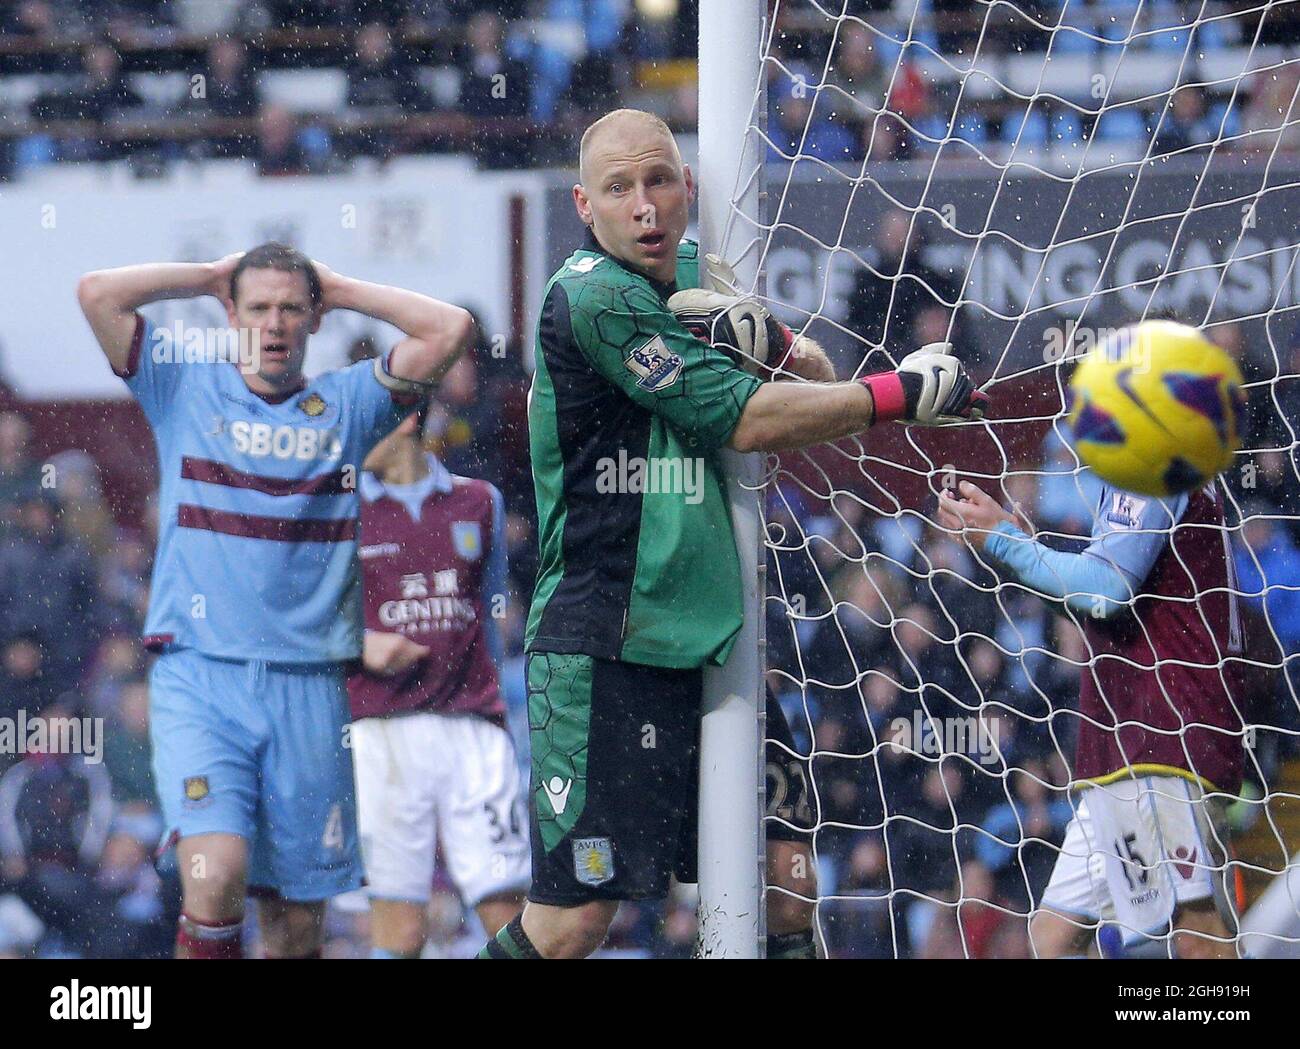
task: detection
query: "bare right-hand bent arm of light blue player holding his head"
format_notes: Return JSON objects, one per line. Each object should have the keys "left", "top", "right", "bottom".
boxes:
{"left": 315, "top": 263, "right": 473, "bottom": 382}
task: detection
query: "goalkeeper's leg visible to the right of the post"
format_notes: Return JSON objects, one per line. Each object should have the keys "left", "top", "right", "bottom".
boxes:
{"left": 763, "top": 689, "right": 816, "bottom": 958}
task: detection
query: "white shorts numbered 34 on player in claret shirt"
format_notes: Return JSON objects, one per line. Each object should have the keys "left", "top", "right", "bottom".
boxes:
{"left": 352, "top": 711, "right": 530, "bottom": 906}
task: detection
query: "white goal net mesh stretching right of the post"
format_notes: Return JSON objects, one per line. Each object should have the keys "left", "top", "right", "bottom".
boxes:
{"left": 725, "top": 0, "right": 1300, "bottom": 957}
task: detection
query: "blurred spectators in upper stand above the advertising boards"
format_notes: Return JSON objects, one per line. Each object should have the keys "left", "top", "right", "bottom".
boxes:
{"left": 0, "top": 0, "right": 1297, "bottom": 177}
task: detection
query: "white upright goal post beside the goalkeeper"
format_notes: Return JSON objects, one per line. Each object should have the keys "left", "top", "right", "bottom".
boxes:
{"left": 696, "top": 0, "right": 766, "bottom": 958}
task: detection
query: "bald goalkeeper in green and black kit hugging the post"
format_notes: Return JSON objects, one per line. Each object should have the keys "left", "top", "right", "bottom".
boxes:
{"left": 478, "top": 109, "right": 988, "bottom": 958}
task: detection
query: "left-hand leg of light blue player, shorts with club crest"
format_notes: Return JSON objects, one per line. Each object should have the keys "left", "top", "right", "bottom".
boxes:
{"left": 150, "top": 649, "right": 260, "bottom": 958}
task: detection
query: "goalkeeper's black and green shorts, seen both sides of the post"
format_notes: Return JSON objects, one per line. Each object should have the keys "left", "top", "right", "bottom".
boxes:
{"left": 528, "top": 653, "right": 811, "bottom": 907}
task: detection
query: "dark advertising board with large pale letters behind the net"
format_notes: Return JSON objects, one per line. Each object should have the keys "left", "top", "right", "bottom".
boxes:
{"left": 547, "top": 156, "right": 1300, "bottom": 377}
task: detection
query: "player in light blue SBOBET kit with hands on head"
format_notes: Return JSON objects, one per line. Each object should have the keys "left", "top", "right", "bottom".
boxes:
{"left": 77, "top": 243, "right": 472, "bottom": 958}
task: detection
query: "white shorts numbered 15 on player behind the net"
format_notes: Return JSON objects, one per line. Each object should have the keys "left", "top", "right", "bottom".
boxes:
{"left": 1041, "top": 776, "right": 1234, "bottom": 940}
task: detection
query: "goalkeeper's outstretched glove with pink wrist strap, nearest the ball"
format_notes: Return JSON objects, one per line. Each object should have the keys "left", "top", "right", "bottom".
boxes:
{"left": 858, "top": 342, "right": 989, "bottom": 426}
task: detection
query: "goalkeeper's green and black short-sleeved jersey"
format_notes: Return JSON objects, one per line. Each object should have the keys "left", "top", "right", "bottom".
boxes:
{"left": 525, "top": 234, "right": 759, "bottom": 668}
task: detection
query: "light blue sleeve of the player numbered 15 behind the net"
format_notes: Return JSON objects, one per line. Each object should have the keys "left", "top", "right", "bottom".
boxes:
{"left": 984, "top": 485, "right": 1187, "bottom": 619}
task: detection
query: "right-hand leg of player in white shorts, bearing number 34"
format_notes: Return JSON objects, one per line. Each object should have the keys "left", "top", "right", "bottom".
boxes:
{"left": 439, "top": 714, "right": 532, "bottom": 936}
